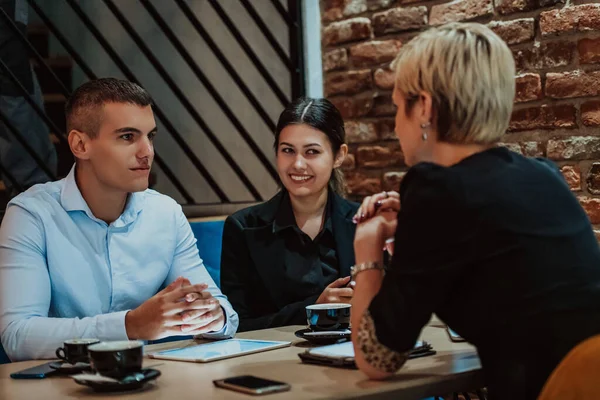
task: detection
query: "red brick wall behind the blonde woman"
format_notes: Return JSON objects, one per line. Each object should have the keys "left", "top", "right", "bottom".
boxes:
{"left": 321, "top": 0, "right": 600, "bottom": 233}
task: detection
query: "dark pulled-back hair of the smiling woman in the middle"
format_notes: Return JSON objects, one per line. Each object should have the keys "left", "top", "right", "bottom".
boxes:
{"left": 274, "top": 97, "right": 346, "bottom": 196}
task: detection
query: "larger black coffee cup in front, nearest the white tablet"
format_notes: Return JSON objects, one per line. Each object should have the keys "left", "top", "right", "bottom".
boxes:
{"left": 88, "top": 340, "right": 144, "bottom": 379}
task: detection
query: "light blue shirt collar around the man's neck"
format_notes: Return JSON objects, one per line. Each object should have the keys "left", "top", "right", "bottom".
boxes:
{"left": 60, "top": 165, "right": 144, "bottom": 228}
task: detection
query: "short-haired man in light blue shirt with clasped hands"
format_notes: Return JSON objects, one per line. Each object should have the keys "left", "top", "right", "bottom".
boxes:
{"left": 0, "top": 78, "right": 238, "bottom": 361}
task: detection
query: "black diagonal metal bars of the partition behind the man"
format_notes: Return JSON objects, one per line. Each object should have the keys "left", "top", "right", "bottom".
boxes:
{"left": 0, "top": 0, "right": 303, "bottom": 212}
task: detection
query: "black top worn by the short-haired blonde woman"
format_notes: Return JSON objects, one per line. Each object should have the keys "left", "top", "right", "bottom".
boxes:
{"left": 369, "top": 148, "right": 600, "bottom": 399}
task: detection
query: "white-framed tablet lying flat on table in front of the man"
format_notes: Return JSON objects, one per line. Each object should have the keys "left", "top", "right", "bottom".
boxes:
{"left": 149, "top": 339, "right": 292, "bottom": 362}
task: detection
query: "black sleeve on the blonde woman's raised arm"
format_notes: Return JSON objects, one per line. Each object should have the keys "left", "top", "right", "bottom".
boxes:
{"left": 369, "top": 164, "right": 478, "bottom": 352}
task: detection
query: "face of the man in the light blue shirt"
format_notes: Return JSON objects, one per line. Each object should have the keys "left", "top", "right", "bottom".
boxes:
{"left": 88, "top": 103, "right": 156, "bottom": 193}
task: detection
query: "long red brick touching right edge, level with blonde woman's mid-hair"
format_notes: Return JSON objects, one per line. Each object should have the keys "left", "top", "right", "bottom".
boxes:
{"left": 546, "top": 70, "right": 600, "bottom": 99}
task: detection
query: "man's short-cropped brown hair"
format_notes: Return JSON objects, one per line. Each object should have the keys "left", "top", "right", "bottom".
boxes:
{"left": 65, "top": 78, "right": 152, "bottom": 138}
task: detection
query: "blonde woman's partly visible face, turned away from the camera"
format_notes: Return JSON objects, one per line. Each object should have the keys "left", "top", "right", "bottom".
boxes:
{"left": 392, "top": 89, "right": 434, "bottom": 166}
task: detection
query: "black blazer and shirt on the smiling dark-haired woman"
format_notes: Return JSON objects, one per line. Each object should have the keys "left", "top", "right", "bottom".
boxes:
{"left": 221, "top": 190, "right": 358, "bottom": 331}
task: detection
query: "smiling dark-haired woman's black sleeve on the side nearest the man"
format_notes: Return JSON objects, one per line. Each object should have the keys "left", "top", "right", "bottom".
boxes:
{"left": 221, "top": 217, "right": 319, "bottom": 332}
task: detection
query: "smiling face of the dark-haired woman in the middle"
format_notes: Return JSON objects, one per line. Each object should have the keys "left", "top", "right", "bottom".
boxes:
{"left": 277, "top": 124, "right": 343, "bottom": 197}
